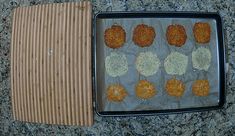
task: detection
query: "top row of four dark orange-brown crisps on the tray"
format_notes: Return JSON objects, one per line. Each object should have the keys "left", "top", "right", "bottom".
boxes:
{"left": 104, "top": 22, "right": 211, "bottom": 49}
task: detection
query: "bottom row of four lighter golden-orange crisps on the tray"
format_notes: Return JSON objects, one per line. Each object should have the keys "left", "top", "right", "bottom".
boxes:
{"left": 106, "top": 78, "right": 210, "bottom": 102}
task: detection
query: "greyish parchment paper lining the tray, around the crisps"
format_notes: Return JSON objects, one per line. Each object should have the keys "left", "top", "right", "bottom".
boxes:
{"left": 97, "top": 18, "right": 219, "bottom": 111}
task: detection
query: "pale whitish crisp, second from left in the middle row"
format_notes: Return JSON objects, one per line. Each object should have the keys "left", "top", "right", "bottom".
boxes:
{"left": 136, "top": 52, "right": 160, "bottom": 76}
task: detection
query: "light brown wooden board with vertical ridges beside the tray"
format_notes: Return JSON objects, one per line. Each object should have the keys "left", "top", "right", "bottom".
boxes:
{"left": 11, "top": 1, "right": 93, "bottom": 126}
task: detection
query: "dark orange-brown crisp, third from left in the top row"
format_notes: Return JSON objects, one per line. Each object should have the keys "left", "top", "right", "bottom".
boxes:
{"left": 166, "top": 24, "right": 187, "bottom": 47}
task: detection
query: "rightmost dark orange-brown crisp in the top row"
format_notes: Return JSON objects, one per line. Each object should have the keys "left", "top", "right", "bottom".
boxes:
{"left": 193, "top": 22, "right": 211, "bottom": 43}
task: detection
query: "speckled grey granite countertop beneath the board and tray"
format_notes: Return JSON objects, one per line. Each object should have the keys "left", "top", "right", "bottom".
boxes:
{"left": 0, "top": 0, "right": 235, "bottom": 136}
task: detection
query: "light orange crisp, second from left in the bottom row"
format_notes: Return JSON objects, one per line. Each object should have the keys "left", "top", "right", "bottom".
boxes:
{"left": 135, "top": 80, "right": 156, "bottom": 99}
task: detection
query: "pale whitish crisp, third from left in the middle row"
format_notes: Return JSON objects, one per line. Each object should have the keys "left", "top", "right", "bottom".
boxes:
{"left": 164, "top": 52, "right": 188, "bottom": 75}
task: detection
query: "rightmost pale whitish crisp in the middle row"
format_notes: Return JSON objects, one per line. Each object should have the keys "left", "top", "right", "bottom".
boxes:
{"left": 192, "top": 47, "right": 211, "bottom": 71}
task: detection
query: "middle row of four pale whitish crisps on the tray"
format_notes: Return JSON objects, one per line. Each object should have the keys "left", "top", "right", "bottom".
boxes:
{"left": 105, "top": 47, "right": 212, "bottom": 77}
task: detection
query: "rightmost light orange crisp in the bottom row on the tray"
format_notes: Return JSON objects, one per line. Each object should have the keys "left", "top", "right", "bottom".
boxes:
{"left": 192, "top": 80, "right": 210, "bottom": 96}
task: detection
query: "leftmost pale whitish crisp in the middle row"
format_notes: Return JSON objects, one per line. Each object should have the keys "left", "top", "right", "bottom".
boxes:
{"left": 105, "top": 52, "right": 128, "bottom": 77}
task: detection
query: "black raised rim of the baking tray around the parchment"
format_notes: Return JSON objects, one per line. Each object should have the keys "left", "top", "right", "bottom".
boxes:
{"left": 92, "top": 11, "right": 226, "bottom": 116}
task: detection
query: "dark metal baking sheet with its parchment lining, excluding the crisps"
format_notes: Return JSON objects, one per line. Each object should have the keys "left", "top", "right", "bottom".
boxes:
{"left": 93, "top": 12, "right": 225, "bottom": 115}
